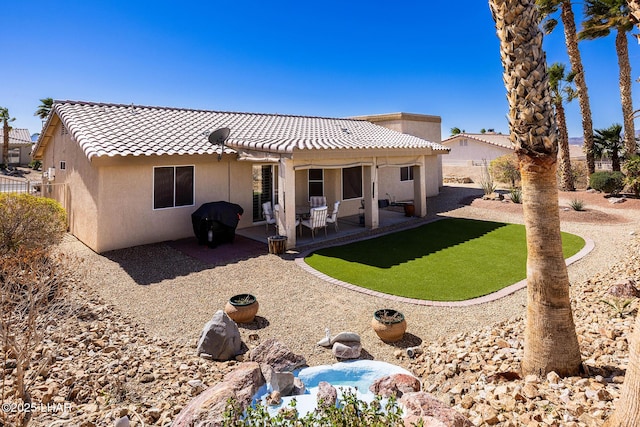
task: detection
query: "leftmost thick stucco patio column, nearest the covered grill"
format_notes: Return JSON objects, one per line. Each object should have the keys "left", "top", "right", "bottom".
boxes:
{"left": 278, "top": 158, "right": 296, "bottom": 249}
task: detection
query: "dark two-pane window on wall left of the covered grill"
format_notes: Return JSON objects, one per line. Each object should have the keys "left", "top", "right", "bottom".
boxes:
{"left": 153, "top": 166, "right": 194, "bottom": 209}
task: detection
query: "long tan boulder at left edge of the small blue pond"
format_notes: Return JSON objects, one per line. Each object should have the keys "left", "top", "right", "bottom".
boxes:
{"left": 172, "top": 362, "right": 264, "bottom": 427}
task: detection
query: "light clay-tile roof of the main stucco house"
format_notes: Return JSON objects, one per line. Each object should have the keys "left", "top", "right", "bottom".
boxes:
{"left": 34, "top": 101, "right": 448, "bottom": 159}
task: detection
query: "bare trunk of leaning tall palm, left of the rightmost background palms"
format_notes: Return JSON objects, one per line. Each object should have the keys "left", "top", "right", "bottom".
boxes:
{"left": 560, "top": 0, "right": 596, "bottom": 175}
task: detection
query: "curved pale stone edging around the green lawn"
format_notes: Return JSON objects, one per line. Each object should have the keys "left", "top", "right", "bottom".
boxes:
{"left": 295, "top": 227, "right": 595, "bottom": 307}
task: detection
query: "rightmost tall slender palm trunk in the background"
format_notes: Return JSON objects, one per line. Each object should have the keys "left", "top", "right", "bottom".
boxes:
{"left": 616, "top": 30, "right": 636, "bottom": 158}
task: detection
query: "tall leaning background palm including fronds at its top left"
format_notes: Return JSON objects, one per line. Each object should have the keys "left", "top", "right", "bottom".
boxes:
{"left": 536, "top": 0, "right": 595, "bottom": 174}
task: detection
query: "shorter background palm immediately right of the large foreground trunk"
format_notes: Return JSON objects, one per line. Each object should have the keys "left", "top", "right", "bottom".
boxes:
{"left": 547, "top": 62, "right": 577, "bottom": 191}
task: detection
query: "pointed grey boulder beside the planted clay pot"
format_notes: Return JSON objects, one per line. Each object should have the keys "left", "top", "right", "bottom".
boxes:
{"left": 197, "top": 310, "right": 242, "bottom": 361}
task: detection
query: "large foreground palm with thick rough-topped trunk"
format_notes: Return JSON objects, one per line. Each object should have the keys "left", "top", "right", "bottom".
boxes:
{"left": 489, "top": 0, "right": 582, "bottom": 376}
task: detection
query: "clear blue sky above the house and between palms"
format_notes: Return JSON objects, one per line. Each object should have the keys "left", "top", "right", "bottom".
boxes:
{"left": 0, "top": 0, "right": 640, "bottom": 137}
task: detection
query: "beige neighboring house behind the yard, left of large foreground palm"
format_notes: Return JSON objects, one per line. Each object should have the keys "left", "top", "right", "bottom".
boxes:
{"left": 442, "top": 132, "right": 514, "bottom": 166}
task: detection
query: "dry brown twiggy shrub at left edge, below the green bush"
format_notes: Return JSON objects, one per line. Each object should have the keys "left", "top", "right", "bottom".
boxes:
{"left": 0, "top": 248, "right": 79, "bottom": 426}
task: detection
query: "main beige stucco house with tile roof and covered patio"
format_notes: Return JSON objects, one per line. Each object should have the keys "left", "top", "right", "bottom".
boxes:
{"left": 34, "top": 101, "right": 448, "bottom": 252}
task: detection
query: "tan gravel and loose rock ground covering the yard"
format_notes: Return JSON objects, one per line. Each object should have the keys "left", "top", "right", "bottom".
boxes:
{"left": 9, "top": 186, "right": 640, "bottom": 426}
